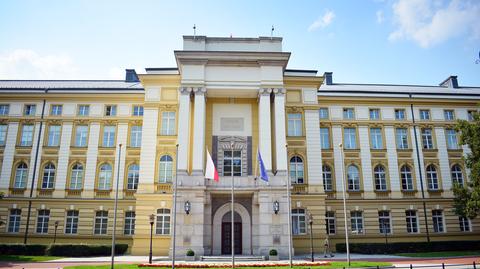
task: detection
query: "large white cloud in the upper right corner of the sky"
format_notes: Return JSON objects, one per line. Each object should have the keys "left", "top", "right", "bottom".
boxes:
{"left": 389, "top": 0, "right": 480, "bottom": 48}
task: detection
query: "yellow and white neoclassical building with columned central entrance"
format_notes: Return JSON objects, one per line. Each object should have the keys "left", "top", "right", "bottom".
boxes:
{"left": 0, "top": 36, "right": 480, "bottom": 256}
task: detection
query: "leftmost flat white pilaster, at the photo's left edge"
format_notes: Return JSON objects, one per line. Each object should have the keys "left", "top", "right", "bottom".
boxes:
{"left": 0, "top": 122, "right": 18, "bottom": 189}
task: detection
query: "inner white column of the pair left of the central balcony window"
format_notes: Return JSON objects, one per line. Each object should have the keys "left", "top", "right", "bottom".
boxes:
{"left": 191, "top": 88, "right": 206, "bottom": 175}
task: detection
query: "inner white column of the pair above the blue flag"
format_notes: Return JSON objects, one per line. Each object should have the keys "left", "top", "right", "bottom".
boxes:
{"left": 253, "top": 88, "right": 272, "bottom": 172}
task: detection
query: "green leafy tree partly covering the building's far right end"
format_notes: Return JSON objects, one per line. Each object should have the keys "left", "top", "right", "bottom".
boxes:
{"left": 453, "top": 113, "right": 480, "bottom": 219}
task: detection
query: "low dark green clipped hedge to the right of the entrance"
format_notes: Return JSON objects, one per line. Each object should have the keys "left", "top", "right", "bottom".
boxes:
{"left": 336, "top": 241, "right": 480, "bottom": 254}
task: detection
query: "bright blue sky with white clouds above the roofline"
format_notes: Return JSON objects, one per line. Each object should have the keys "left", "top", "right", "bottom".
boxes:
{"left": 0, "top": 0, "right": 480, "bottom": 86}
